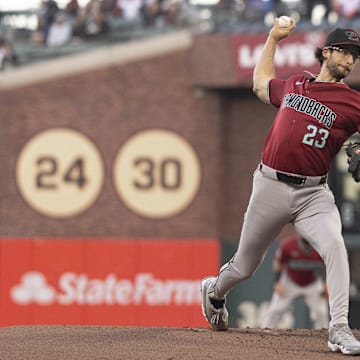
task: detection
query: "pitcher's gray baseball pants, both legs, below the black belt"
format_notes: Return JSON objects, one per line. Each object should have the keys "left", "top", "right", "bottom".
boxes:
{"left": 214, "top": 165, "right": 350, "bottom": 326}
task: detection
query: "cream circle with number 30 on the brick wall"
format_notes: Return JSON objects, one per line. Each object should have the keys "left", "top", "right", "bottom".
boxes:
{"left": 113, "top": 129, "right": 201, "bottom": 218}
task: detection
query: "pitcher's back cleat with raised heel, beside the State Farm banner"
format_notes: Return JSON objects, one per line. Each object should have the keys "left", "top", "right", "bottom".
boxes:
{"left": 201, "top": 277, "right": 229, "bottom": 331}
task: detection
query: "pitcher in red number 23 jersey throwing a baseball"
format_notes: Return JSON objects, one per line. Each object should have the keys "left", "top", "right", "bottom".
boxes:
{"left": 201, "top": 19, "right": 360, "bottom": 355}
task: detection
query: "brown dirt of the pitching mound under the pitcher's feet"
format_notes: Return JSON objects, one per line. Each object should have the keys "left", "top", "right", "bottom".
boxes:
{"left": 0, "top": 326, "right": 360, "bottom": 360}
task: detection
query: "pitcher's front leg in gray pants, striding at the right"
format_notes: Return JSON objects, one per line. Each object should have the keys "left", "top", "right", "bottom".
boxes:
{"left": 295, "top": 204, "right": 350, "bottom": 326}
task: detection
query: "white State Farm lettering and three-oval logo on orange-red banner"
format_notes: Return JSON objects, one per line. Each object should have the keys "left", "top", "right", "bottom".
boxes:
{"left": 10, "top": 271, "right": 201, "bottom": 306}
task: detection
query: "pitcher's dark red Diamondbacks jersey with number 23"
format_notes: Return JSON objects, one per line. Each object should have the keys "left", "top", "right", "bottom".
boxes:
{"left": 262, "top": 75, "right": 360, "bottom": 176}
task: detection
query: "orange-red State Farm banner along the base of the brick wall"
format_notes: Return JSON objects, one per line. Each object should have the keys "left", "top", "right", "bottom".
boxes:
{"left": 0, "top": 239, "right": 219, "bottom": 326}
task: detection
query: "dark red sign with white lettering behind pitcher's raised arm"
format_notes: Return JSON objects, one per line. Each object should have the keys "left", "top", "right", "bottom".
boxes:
{"left": 230, "top": 32, "right": 326, "bottom": 81}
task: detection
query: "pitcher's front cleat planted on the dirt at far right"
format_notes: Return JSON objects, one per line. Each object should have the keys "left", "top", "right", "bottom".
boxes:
{"left": 328, "top": 324, "right": 360, "bottom": 355}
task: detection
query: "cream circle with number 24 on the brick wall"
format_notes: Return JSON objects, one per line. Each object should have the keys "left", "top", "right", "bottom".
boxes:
{"left": 16, "top": 128, "right": 104, "bottom": 218}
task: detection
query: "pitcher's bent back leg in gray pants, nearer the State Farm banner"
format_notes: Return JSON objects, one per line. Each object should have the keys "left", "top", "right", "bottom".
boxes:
{"left": 213, "top": 171, "right": 290, "bottom": 299}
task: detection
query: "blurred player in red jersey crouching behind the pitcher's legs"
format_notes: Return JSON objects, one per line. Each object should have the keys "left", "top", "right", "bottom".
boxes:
{"left": 263, "top": 234, "right": 329, "bottom": 329}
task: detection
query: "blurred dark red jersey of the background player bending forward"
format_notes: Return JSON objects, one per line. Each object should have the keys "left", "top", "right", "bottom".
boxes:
{"left": 275, "top": 236, "right": 323, "bottom": 286}
